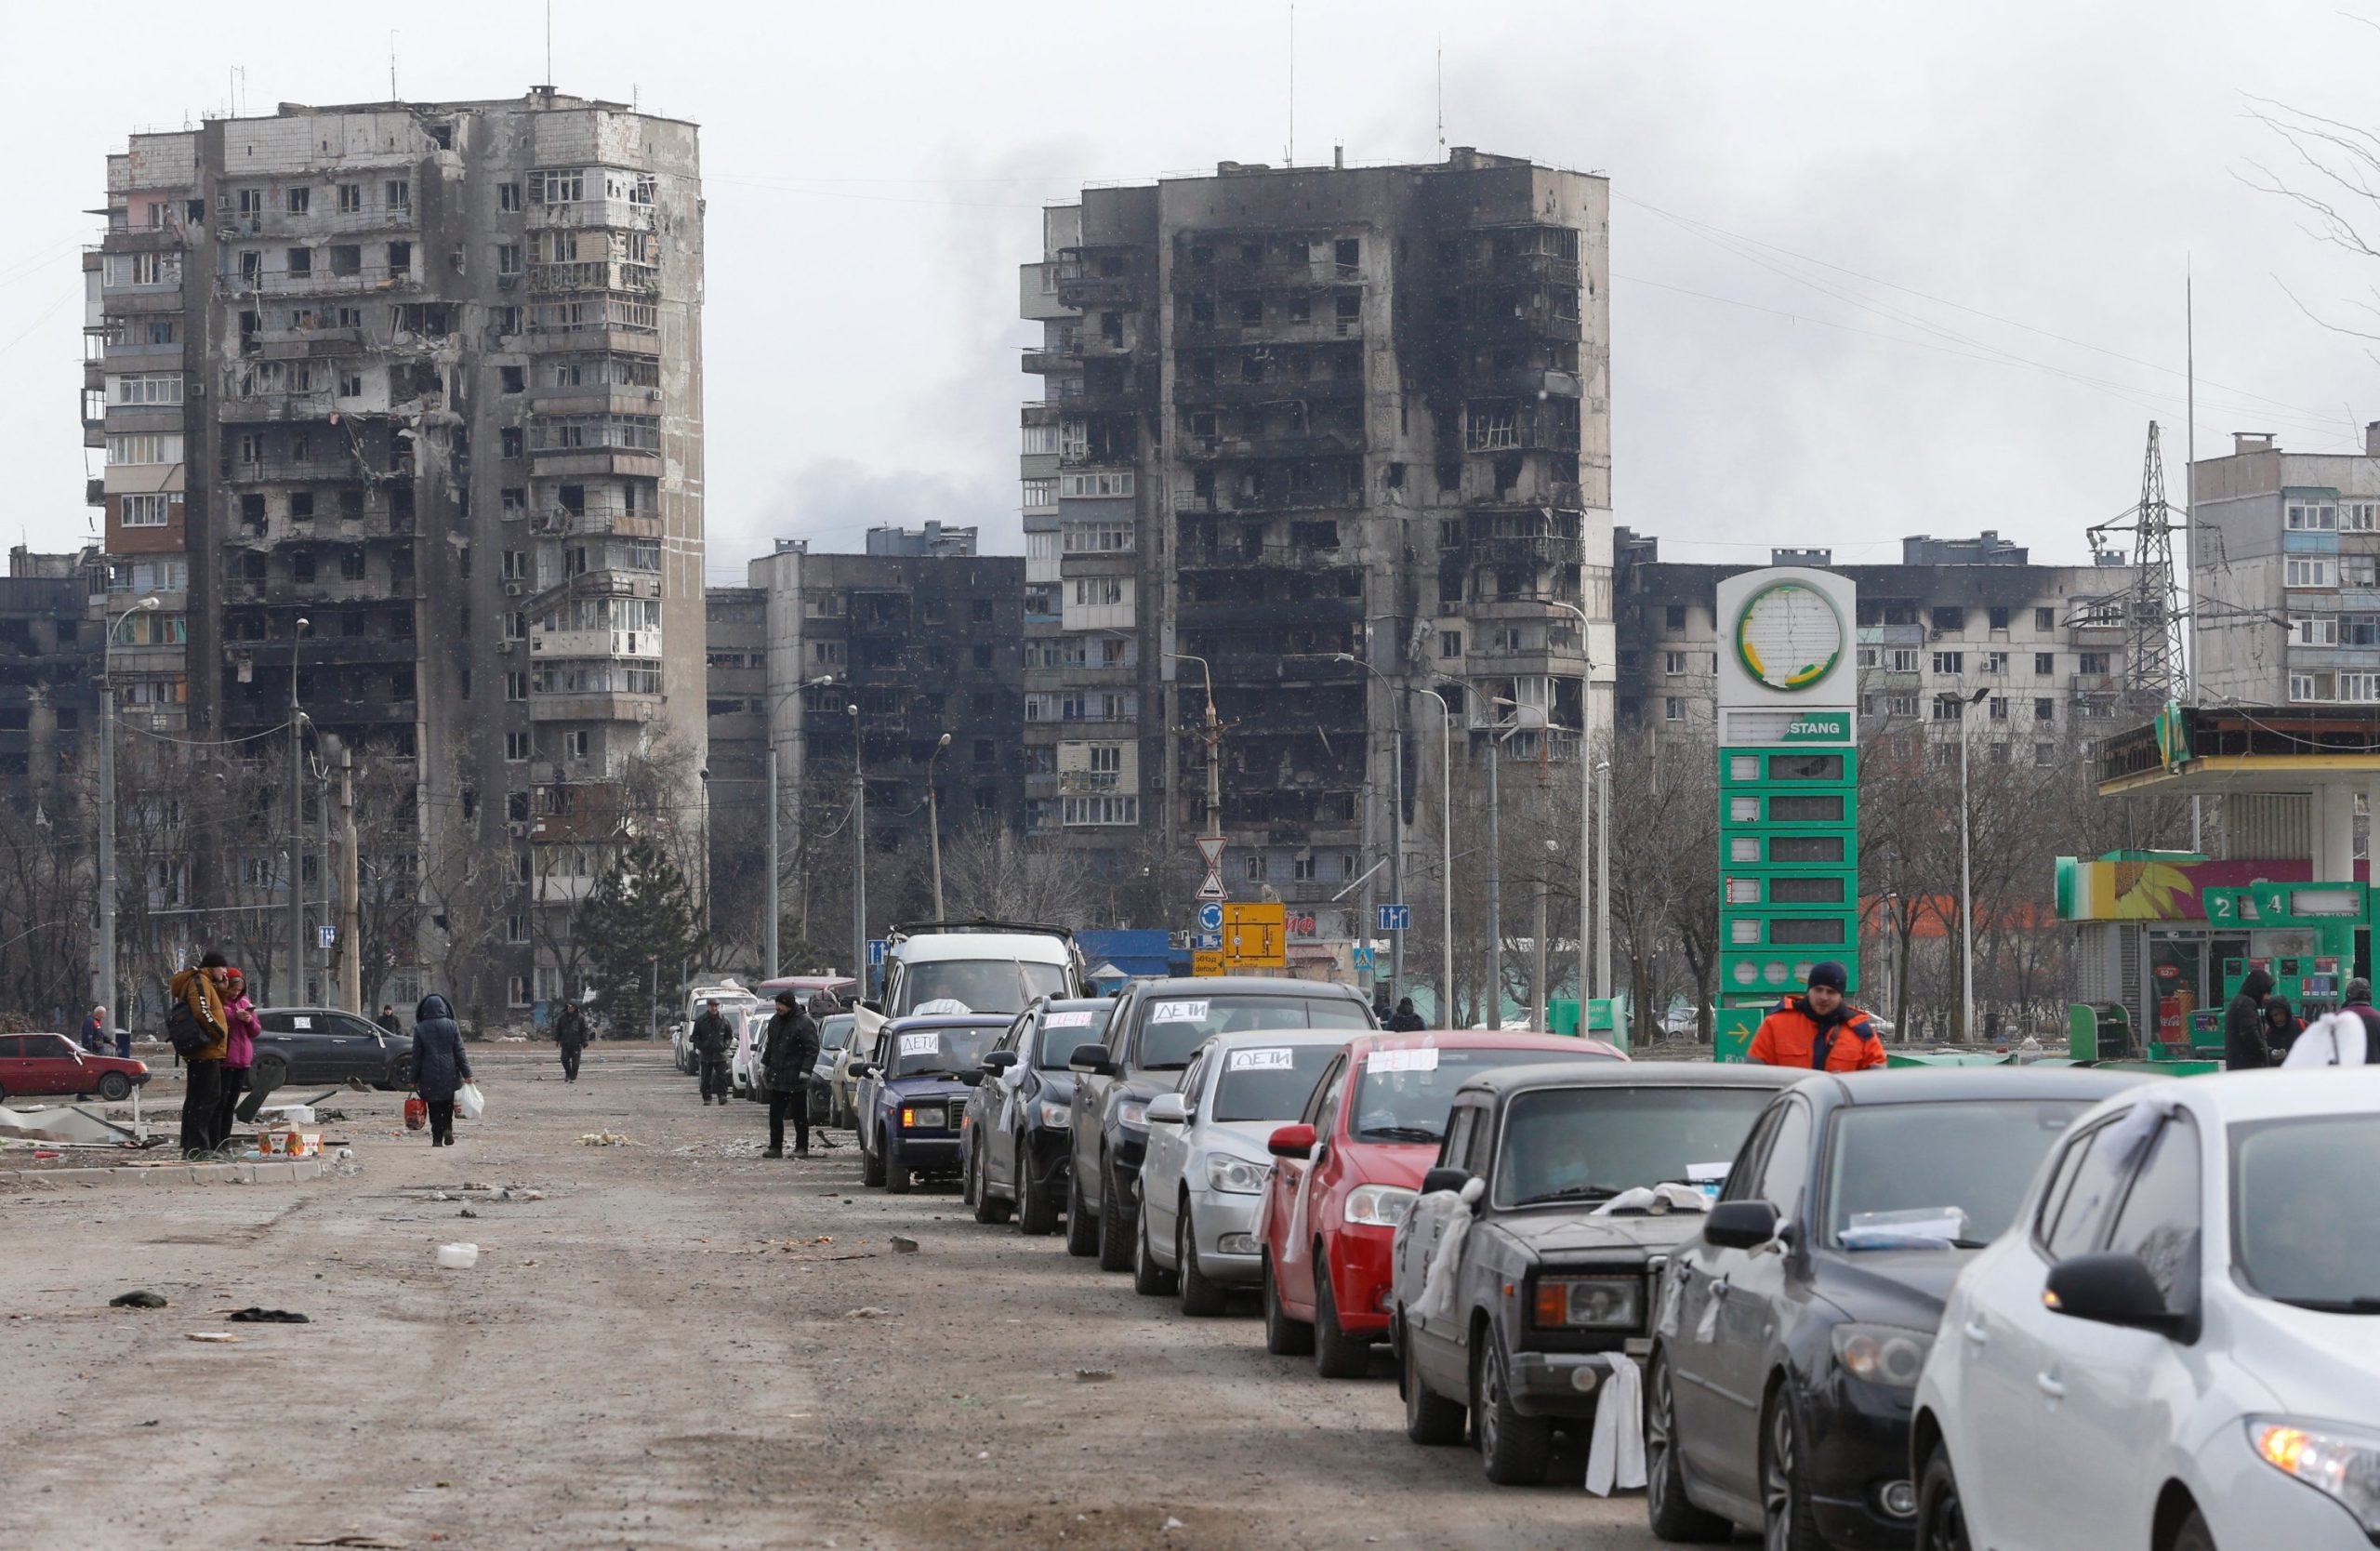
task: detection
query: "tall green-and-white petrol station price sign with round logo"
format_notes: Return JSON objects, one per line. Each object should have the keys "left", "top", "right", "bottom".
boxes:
{"left": 1716, "top": 566, "right": 1858, "bottom": 1061}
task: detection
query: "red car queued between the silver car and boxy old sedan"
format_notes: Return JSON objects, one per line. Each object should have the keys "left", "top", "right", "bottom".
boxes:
{"left": 1257, "top": 1030, "right": 1628, "bottom": 1380}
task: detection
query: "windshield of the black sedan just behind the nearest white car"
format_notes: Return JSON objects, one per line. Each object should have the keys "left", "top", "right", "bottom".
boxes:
{"left": 1826, "top": 1099, "right": 2085, "bottom": 1249}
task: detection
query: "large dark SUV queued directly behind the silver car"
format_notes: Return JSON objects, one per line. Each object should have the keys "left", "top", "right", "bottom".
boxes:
{"left": 1066, "top": 975, "right": 1381, "bottom": 1270}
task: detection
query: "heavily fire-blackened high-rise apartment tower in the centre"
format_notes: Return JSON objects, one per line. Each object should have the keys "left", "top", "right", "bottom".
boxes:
{"left": 1021, "top": 148, "right": 1611, "bottom": 940}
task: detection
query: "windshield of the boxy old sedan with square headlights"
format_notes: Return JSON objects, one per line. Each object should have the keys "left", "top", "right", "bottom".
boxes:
{"left": 1495, "top": 1085, "right": 1776, "bottom": 1206}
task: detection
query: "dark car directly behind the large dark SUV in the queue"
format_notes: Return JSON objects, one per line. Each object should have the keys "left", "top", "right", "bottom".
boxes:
{"left": 959, "top": 997, "right": 1117, "bottom": 1235}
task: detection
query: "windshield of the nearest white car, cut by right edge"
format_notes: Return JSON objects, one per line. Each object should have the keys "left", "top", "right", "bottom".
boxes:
{"left": 2230, "top": 1116, "right": 2380, "bottom": 1313}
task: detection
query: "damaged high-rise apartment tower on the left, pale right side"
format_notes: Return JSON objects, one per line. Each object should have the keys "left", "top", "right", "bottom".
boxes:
{"left": 84, "top": 97, "right": 705, "bottom": 1021}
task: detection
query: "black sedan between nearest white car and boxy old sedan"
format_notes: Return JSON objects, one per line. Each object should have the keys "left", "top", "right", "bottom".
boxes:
{"left": 1645, "top": 1066, "right": 2139, "bottom": 1551}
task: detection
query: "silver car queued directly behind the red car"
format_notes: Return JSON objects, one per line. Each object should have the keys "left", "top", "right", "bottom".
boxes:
{"left": 1133, "top": 1027, "right": 1368, "bottom": 1316}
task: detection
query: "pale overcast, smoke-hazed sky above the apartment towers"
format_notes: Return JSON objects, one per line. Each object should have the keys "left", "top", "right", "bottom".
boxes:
{"left": 14, "top": 0, "right": 2380, "bottom": 583}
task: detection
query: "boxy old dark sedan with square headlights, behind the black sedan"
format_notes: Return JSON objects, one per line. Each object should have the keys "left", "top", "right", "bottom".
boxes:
{"left": 1390, "top": 1061, "right": 1806, "bottom": 1484}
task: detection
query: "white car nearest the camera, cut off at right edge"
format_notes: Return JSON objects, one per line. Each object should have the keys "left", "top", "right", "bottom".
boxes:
{"left": 1911, "top": 1066, "right": 2380, "bottom": 1551}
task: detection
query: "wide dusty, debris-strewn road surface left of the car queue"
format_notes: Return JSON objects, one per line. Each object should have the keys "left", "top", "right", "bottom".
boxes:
{"left": 0, "top": 1047, "right": 1654, "bottom": 1551}
